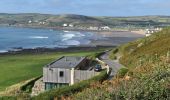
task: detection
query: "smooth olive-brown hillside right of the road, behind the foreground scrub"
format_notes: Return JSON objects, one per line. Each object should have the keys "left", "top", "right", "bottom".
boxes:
{"left": 120, "top": 29, "right": 170, "bottom": 67}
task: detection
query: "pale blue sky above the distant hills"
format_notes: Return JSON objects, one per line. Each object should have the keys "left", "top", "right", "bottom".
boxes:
{"left": 0, "top": 0, "right": 170, "bottom": 16}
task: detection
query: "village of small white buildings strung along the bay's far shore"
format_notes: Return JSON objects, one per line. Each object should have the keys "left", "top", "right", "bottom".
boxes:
{"left": 26, "top": 20, "right": 162, "bottom": 37}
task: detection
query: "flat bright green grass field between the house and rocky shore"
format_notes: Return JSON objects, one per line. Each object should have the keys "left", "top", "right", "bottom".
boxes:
{"left": 0, "top": 51, "right": 101, "bottom": 91}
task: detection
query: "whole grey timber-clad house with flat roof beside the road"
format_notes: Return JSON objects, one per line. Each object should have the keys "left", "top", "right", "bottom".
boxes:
{"left": 43, "top": 56, "right": 97, "bottom": 90}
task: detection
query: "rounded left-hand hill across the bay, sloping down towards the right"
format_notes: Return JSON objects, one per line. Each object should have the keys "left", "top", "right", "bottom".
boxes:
{"left": 0, "top": 14, "right": 107, "bottom": 26}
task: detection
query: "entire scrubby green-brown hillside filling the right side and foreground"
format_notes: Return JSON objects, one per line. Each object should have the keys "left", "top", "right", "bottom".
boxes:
{"left": 69, "top": 28, "right": 170, "bottom": 100}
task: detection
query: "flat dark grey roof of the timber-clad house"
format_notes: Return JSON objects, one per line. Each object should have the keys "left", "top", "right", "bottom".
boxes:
{"left": 45, "top": 56, "right": 86, "bottom": 69}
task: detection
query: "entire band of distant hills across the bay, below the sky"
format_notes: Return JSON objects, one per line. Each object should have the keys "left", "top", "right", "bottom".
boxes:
{"left": 0, "top": 13, "right": 170, "bottom": 28}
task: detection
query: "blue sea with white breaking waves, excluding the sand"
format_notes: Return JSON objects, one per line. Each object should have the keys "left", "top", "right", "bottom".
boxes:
{"left": 0, "top": 27, "right": 102, "bottom": 53}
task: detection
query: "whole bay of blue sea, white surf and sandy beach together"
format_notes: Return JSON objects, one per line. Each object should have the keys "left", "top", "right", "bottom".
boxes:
{"left": 0, "top": 27, "right": 144, "bottom": 54}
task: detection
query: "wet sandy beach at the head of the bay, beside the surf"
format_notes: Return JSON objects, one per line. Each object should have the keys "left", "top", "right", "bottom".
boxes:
{"left": 89, "top": 31, "right": 145, "bottom": 46}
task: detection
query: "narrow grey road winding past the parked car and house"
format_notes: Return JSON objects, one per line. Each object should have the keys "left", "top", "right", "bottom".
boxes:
{"left": 100, "top": 51, "right": 123, "bottom": 79}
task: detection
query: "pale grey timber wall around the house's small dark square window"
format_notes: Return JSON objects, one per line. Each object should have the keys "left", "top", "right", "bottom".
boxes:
{"left": 43, "top": 67, "right": 71, "bottom": 83}
